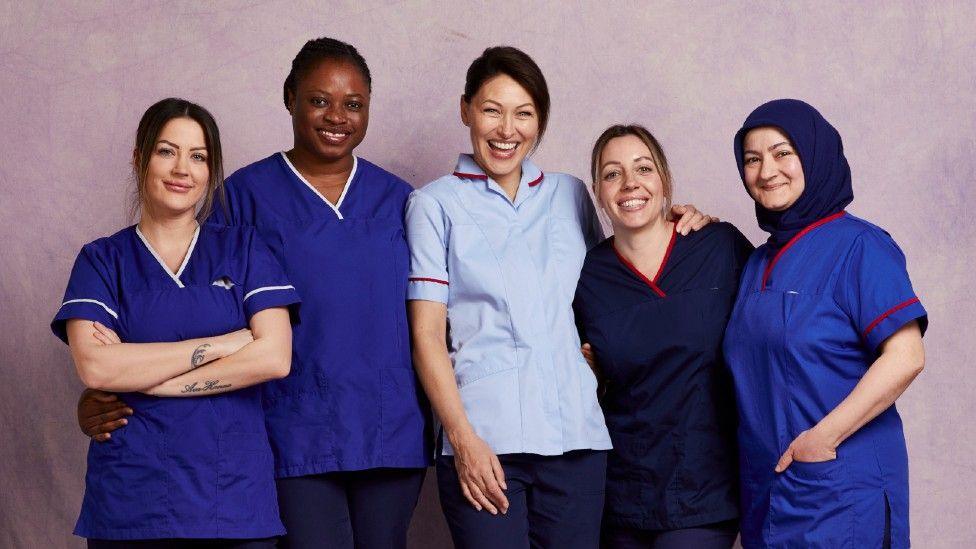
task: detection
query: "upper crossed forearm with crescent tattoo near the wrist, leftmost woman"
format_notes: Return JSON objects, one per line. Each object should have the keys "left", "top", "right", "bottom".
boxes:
{"left": 72, "top": 337, "right": 223, "bottom": 391}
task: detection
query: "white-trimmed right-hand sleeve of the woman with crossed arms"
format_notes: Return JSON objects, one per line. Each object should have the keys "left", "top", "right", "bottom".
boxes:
{"left": 242, "top": 229, "right": 301, "bottom": 324}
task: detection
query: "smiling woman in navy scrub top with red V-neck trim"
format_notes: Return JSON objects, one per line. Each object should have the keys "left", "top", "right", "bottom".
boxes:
{"left": 574, "top": 125, "right": 752, "bottom": 549}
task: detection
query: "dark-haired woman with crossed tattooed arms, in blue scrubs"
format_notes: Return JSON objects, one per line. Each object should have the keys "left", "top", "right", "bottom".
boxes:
{"left": 51, "top": 99, "right": 299, "bottom": 548}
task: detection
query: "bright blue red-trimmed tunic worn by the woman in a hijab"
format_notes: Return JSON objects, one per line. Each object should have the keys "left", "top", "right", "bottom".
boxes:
{"left": 724, "top": 212, "right": 927, "bottom": 548}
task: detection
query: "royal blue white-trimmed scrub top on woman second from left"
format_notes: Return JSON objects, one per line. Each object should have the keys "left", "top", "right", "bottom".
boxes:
{"left": 213, "top": 153, "right": 432, "bottom": 478}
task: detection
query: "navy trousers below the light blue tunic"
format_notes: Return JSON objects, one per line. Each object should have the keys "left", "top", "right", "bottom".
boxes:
{"left": 437, "top": 450, "right": 607, "bottom": 549}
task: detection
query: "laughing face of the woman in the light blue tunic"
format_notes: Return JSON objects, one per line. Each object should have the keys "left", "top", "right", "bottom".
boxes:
{"left": 461, "top": 74, "right": 539, "bottom": 183}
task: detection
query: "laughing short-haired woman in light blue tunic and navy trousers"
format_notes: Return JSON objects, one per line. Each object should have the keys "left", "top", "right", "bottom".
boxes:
{"left": 407, "top": 47, "right": 706, "bottom": 548}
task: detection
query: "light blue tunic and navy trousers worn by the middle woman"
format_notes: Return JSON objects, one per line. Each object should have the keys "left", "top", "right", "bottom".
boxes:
{"left": 407, "top": 155, "right": 610, "bottom": 547}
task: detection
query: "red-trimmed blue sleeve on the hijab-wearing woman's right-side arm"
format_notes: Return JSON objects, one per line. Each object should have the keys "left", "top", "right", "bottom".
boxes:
{"left": 834, "top": 230, "right": 928, "bottom": 351}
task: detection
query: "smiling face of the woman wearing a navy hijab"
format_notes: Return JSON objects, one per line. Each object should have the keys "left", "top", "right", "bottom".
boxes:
{"left": 742, "top": 126, "right": 805, "bottom": 212}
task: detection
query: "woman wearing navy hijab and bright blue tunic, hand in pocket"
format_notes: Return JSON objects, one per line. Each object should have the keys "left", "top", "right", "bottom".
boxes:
{"left": 724, "top": 99, "right": 928, "bottom": 548}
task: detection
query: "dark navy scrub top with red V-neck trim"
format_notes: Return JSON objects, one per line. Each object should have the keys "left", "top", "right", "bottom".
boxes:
{"left": 574, "top": 223, "right": 753, "bottom": 530}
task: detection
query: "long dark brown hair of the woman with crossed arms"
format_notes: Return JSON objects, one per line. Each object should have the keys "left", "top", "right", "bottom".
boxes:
{"left": 131, "top": 97, "right": 227, "bottom": 222}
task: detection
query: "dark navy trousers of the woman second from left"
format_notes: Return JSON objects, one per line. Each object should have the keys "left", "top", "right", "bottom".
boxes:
{"left": 277, "top": 469, "right": 427, "bottom": 549}
